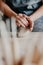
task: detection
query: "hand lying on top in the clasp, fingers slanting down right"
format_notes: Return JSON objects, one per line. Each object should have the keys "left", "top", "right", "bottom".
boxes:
{"left": 16, "top": 14, "right": 28, "bottom": 28}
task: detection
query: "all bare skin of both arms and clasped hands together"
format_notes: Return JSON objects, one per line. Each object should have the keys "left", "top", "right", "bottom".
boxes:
{"left": 0, "top": 1, "right": 43, "bottom": 30}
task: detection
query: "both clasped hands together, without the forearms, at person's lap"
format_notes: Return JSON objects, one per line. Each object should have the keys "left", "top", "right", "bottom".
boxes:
{"left": 16, "top": 14, "right": 34, "bottom": 31}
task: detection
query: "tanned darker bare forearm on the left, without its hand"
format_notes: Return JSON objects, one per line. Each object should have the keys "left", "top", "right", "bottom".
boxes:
{"left": 0, "top": 2, "right": 17, "bottom": 17}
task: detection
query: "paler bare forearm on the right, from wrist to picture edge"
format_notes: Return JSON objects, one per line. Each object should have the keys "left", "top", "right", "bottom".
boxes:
{"left": 30, "top": 5, "right": 43, "bottom": 21}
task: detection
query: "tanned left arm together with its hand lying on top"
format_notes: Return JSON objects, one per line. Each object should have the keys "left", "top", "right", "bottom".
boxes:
{"left": 0, "top": 1, "right": 32, "bottom": 29}
